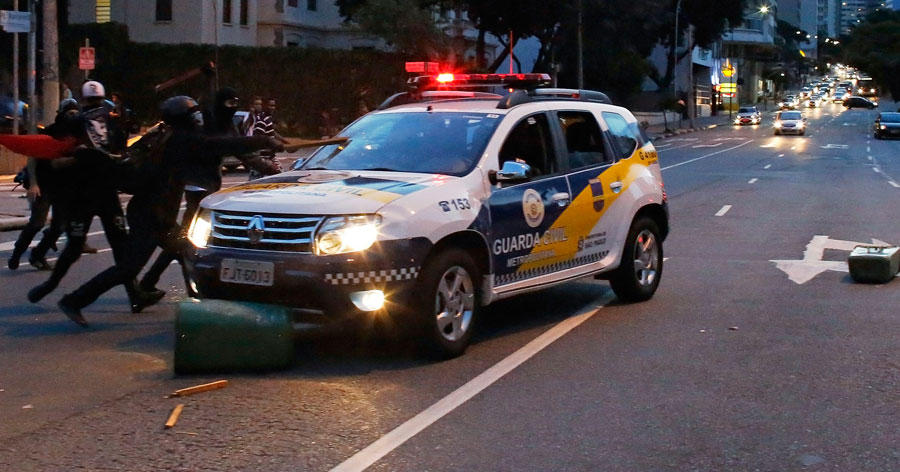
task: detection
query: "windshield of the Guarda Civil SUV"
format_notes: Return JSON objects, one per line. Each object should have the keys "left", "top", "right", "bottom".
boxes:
{"left": 294, "top": 112, "right": 500, "bottom": 176}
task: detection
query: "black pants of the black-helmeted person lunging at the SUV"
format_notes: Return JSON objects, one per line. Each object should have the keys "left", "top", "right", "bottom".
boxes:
{"left": 63, "top": 205, "right": 180, "bottom": 309}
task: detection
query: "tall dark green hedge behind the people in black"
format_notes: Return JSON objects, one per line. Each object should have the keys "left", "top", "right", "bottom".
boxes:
{"left": 60, "top": 25, "right": 406, "bottom": 136}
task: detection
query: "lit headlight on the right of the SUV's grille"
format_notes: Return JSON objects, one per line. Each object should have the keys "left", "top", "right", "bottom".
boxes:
{"left": 316, "top": 215, "right": 381, "bottom": 255}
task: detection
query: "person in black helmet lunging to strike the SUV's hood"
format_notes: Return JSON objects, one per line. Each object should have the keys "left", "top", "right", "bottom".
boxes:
{"left": 58, "top": 96, "right": 283, "bottom": 327}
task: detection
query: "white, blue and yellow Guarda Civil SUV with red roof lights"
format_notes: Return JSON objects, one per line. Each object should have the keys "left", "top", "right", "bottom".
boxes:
{"left": 188, "top": 74, "right": 669, "bottom": 357}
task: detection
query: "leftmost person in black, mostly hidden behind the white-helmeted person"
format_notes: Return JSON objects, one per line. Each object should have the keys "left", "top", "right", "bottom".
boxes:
{"left": 7, "top": 98, "right": 79, "bottom": 270}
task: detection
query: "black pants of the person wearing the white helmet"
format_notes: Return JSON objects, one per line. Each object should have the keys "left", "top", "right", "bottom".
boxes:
{"left": 39, "top": 190, "right": 135, "bottom": 296}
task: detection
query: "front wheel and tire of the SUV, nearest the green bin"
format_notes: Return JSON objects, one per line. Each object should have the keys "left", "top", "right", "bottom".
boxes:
{"left": 410, "top": 249, "right": 481, "bottom": 359}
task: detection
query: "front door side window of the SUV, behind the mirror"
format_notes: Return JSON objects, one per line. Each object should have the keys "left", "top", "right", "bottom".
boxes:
{"left": 499, "top": 113, "right": 556, "bottom": 177}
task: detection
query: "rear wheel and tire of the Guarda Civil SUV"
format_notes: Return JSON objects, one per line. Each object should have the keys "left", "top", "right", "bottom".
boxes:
{"left": 609, "top": 217, "right": 663, "bottom": 302}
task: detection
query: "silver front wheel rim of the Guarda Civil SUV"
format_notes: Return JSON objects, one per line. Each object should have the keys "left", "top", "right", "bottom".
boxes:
{"left": 434, "top": 266, "right": 475, "bottom": 341}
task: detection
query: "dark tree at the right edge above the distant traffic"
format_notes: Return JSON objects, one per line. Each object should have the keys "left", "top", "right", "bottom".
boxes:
{"left": 843, "top": 11, "right": 900, "bottom": 101}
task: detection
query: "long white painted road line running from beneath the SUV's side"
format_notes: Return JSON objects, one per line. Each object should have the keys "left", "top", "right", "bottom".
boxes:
{"left": 331, "top": 294, "right": 613, "bottom": 472}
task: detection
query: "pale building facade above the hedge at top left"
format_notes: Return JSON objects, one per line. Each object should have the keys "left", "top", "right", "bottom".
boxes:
{"left": 69, "top": 0, "right": 500, "bottom": 62}
